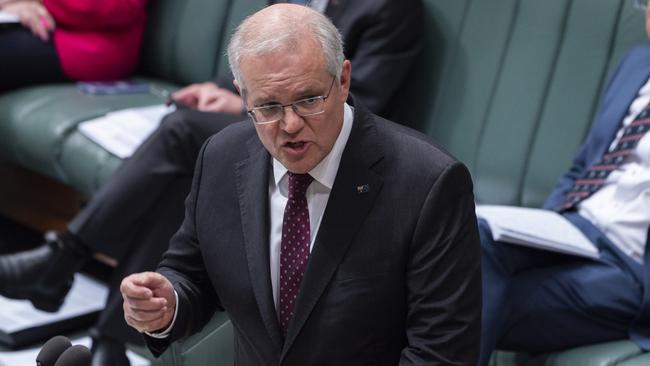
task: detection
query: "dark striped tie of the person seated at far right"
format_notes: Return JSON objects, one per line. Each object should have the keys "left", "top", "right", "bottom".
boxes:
{"left": 560, "top": 104, "right": 650, "bottom": 211}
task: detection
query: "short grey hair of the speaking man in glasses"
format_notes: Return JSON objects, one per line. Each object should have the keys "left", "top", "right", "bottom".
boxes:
{"left": 228, "top": 4, "right": 345, "bottom": 92}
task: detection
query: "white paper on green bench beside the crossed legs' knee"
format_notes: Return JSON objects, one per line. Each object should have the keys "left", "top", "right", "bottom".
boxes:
{"left": 79, "top": 104, "right": 175, "bottom": 159}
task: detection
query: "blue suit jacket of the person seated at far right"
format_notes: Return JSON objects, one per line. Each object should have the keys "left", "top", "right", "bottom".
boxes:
{"left": 544, "top": 46, "right": 650, "bottom": 350}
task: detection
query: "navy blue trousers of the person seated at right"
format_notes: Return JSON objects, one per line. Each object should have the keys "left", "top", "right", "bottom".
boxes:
{"left": 479, "top": 214, "right": 643, "bottom": 365}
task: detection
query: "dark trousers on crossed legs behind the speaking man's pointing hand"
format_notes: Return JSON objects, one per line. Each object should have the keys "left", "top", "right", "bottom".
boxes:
{"left": 68, "top": 109, "right": 246, "bottom": 342}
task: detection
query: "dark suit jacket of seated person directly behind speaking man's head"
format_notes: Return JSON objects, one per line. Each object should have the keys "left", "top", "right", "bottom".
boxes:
{"left": 217, "top": 0, "right": 423, "bottom": 116}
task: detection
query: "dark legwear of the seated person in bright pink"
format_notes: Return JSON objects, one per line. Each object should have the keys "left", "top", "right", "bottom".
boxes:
{"left": 0, "top": 25, "right": 68, "bottom": 93}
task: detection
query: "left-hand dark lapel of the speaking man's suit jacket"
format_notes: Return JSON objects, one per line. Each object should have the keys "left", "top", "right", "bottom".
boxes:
{"left": 235, "top": 136, "right": 282, "bottom": 350}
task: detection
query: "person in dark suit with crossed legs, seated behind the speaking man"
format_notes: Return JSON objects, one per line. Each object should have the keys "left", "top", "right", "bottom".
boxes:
{"left": 0, "top": 0, "right": 422, "bottom": 365}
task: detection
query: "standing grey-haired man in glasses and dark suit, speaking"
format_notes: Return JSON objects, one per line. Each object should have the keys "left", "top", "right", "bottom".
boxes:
{"left": 121, "top": 4, "right": 480, "bottom": 366}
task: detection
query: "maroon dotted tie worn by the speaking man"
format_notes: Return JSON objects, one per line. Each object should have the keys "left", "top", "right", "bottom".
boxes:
{"left": 278, "top": 172, "right": 313, "bottom": 333}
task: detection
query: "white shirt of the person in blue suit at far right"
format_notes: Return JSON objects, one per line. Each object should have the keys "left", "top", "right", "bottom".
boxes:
{"left": 578, "top": 80, "right": 650, "bottom": 263}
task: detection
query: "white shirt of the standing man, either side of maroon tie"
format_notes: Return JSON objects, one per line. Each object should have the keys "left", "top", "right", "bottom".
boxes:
{"left": 269, "top": 103, "right": 354, "bottom": 308}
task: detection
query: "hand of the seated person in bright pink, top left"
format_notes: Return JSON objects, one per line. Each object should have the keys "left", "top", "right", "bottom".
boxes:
{"left": 0, "top": 1, "right": 55, "bottom": 42}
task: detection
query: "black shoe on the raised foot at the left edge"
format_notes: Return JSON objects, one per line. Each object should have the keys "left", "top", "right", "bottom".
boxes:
{"left": 0, "top": 232, "right": 89, "bottom": 312}
